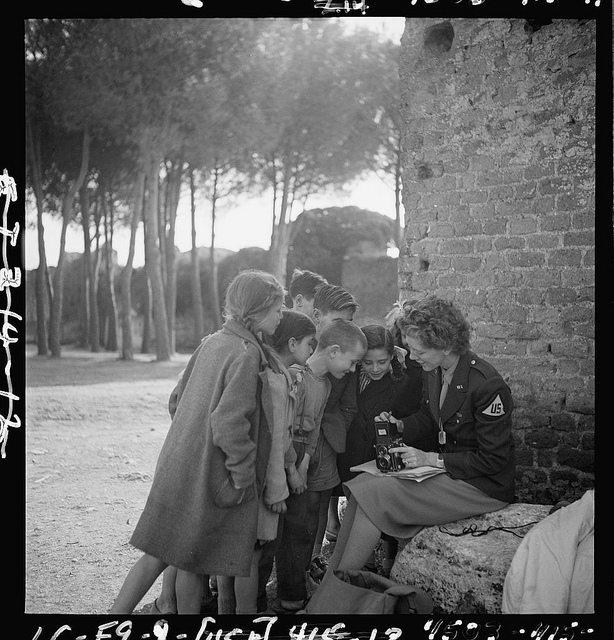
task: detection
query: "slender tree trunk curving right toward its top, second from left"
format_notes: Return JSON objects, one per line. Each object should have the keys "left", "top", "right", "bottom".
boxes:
{"left": 49, "top": 130, "right": 90, "bottom": 358}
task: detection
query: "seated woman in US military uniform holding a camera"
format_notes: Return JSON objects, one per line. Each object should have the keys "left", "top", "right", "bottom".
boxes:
{"left": 329, "top": 296, "right": 515, "bottom": 571}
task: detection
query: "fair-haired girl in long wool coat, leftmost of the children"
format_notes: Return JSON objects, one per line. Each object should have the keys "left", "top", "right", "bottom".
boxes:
{"left": 109, "top": 270, "right": 284, "bottom": 614}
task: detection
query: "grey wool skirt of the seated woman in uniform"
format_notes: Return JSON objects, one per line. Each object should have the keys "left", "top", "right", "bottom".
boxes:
{"left": 343, "top": 473, "right": 509, "bottom": 539}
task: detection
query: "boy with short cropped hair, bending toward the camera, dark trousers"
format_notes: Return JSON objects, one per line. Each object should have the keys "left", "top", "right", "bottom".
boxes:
{"left": 275, "top": 319, "right": 367, "bottom": 612}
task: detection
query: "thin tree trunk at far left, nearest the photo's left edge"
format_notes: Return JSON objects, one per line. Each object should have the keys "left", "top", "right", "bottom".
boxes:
{"left": 26, "top": 118, "right": 51, "bottom": 356}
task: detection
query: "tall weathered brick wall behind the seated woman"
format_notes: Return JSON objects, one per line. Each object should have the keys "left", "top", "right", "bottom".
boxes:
{"left": 399, "top": 19, "right": 595, "bottom": 503}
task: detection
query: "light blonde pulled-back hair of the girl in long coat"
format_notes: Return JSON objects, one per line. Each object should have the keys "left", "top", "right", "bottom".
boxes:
{"left": 224, "top": 269, "right": 285, "bottom": 332}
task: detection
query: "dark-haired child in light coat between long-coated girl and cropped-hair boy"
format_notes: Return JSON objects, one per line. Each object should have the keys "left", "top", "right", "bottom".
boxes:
{"left": 217, "top": 309, "right": 316, "bottom": 614}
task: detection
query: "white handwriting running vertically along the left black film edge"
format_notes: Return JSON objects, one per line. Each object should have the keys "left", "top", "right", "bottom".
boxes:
{"left": 0, "top": 169, "right": 21, "bottom": 458}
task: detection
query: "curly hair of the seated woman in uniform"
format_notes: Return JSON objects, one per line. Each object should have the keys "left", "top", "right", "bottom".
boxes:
{"left": 398, "top": 295, "right": 470, "bottom": 355}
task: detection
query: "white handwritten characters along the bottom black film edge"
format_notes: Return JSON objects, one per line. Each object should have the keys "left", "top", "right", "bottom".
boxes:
{"left": 32, "top": 616, "right": 594, "bottom": 640}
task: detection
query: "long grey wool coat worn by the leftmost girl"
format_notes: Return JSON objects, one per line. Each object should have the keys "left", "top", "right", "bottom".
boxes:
{"left": 131, "top": 320, "right": 272, "bottom": 576}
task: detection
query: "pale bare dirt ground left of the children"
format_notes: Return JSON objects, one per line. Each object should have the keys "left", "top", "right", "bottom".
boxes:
{"left": 25, "top": 348, "right": 342, "bottom": 614}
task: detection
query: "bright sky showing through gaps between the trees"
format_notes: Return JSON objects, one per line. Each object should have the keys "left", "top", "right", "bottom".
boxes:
{"left": 24, "top": 16, "right": 405, "bottom": 269}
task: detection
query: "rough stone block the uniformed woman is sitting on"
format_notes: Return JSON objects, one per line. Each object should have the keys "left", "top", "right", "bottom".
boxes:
{"left": 390, "top": 503, "right": 552, "bottom": 614}
